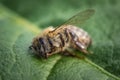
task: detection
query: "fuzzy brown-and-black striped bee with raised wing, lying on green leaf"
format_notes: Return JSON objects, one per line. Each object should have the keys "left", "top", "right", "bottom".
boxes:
{"left": 30, "top": 9, "right": 95, "bottom": 58}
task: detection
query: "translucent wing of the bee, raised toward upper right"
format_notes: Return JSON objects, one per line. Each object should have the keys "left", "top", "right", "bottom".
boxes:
{"left": 54, "top": 9, "right": 95, "bottom": 31}
